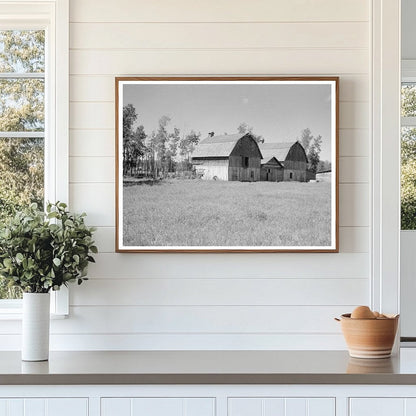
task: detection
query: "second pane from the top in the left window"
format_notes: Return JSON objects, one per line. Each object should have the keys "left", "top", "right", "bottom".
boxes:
{"left": 0, "top": 78, "right": 45, "bottom": 132}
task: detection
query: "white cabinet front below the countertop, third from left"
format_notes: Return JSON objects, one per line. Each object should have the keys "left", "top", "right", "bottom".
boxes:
{"left": 228, "top": 397, "right": 335, "bottom": 416}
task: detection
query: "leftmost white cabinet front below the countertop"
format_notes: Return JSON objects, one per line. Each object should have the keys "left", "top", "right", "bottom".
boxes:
{"left": 0, "top": 398, "right": 88, "bottom": 416}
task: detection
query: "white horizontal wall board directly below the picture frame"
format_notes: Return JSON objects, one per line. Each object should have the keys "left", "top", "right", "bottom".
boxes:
{"left": 87, "top": 252, "right": 368, "bottom": 279}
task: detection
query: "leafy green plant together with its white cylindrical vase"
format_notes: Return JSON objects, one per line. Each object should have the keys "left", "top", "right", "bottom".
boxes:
{"left": 0, "top": 202, "right": 97, "bottom": 361}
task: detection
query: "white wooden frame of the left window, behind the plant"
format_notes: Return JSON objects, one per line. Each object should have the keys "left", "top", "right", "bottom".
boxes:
{"left": 0, "top": 0, "right": 69, "bottom": 320}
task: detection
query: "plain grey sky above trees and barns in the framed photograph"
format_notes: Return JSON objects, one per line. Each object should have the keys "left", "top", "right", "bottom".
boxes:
{"left": 123, "top": 82, "right": 331, "bottom": 160}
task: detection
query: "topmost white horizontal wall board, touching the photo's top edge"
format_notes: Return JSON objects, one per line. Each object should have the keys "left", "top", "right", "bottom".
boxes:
{"left": 70, "top": 0, "right": 370, "bottom": 23}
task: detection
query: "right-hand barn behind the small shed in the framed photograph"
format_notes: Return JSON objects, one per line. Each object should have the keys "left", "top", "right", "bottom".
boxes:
{"left": 260, "top": 142, "right": 308, "bottom": 182}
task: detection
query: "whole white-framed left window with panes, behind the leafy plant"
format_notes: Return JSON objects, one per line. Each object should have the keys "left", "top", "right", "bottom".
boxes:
{"left": 0, "top": 0, "right": 68, "bottom": 313}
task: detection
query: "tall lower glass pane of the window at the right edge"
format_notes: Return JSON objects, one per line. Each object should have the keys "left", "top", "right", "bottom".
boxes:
{"left": 401, "top": 127, "right": 416, "bottom": 230}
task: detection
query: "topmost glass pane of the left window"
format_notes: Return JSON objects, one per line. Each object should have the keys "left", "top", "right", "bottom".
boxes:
{"left": 0, "top": 30, "right": 45, "bottom": 72}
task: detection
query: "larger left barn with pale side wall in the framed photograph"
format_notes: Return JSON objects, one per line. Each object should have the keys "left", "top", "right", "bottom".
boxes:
{"left": 192, "top": 133, "right": 262, "bottom": 182}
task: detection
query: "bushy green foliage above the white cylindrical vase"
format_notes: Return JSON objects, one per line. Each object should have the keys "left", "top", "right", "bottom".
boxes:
{"left": 0, "top": 202, "right": 97, "bottom": 293}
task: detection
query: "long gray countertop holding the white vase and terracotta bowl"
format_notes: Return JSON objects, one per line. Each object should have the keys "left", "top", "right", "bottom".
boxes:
{"left": 0, "top": 349, "right": 416, "bottom": 385}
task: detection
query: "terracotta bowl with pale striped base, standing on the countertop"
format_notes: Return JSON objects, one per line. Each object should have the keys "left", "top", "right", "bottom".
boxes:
{"left": 340, "top": 313, "right": 399, "bottom": 358}
